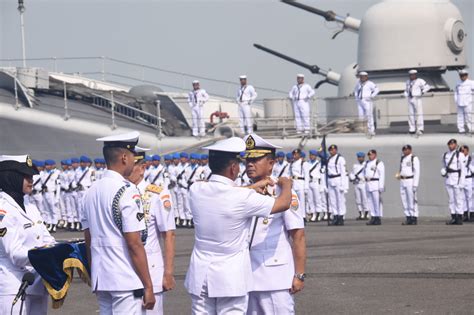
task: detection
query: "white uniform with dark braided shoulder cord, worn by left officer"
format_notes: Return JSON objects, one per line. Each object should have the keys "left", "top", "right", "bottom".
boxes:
{"left": 81, "top": 170, "right": 146, "bottom": 314}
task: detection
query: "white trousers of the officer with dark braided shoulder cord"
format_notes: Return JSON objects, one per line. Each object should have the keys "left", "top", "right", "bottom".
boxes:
{"left": 96, "top": 291, "right": 145, "bottom": 315}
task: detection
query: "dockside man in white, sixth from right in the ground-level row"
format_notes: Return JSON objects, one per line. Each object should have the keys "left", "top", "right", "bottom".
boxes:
{"left": 327, "top": 144, "right": 349, "bottom": 225}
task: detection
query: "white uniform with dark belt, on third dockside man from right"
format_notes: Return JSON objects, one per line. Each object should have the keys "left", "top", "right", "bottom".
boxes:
{"left": 400, "top": 154, "right": 420, "bottom": 218}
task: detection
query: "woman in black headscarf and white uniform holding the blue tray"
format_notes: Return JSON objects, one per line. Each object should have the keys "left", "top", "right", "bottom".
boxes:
{"left": 0, "top": 155, "right": 55, "bottom": 315}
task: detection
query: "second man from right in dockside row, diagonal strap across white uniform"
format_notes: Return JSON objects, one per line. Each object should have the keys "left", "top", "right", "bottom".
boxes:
{"left": 441, "top": 139, "right": 466, "bottom": 225}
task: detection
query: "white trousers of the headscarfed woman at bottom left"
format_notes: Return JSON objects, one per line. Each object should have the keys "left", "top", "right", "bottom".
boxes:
{"left": 0, "top": 294, "right": 48, "bottom": 315}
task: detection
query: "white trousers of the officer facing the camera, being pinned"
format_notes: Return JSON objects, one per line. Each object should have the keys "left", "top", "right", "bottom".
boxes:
{"left": 247, "top": 290, "right": 295, "bottom": 315}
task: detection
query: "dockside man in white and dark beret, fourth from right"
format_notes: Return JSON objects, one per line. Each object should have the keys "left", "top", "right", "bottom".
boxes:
{"left": 364, "top": 150, "right": 385, "bottom": 225}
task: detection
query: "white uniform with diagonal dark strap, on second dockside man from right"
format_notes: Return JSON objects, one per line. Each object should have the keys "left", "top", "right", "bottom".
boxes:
{"left": 442, "top": 150, "right": 466, "bottom": 214}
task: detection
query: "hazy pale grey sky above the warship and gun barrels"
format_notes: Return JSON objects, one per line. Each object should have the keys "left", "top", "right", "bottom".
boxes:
{"left": 0, "top": 0, "right": 474, "bottom": 96}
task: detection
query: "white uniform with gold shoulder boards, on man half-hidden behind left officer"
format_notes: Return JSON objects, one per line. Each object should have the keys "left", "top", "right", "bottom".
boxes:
{"left": 137, "top": 180, "right": 176, "bottom": 315}
